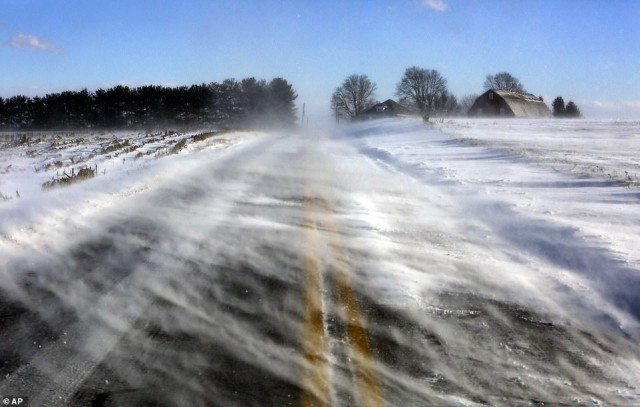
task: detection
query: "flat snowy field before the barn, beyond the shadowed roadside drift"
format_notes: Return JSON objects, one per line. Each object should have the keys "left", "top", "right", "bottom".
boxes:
{"left": 435, "top": 119, "right": 640, "bottom": 186}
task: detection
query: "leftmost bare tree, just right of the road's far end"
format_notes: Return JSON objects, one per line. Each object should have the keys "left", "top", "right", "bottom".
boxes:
{"left": 331, "top": 74, "right": 377, "bottom": 119}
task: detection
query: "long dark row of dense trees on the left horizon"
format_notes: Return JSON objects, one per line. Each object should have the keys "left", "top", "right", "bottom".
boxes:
{"left": 0, "top": 77, "right": 298, "bottom": 130}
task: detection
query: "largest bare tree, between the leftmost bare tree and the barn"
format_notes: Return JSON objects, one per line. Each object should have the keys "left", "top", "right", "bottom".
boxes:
{"left": 396, "top": 66, "right": 447, "bottom": 114}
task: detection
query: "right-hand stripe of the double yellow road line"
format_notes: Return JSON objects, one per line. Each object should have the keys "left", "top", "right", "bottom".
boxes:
{"left": 321, "top": 198, "right": 384, "bottom": 407}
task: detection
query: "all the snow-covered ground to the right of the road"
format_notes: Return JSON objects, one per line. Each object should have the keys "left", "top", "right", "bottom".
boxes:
{"left": 349, "top": 119, "right": 640, "bottom": 330}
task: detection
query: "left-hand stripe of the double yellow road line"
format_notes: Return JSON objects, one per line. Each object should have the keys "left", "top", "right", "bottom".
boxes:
{"left": 300, "top": 195, "right": 329, "bottom": 407}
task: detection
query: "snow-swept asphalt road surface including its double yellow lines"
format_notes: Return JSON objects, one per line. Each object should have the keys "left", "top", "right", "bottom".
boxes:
{"left": 0, "top": 126, "right": 640, "bottom": 406}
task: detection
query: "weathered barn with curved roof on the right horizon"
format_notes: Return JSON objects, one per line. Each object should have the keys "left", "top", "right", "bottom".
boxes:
{"left": 468, "top": 89, "right": 552, "bottom": 117}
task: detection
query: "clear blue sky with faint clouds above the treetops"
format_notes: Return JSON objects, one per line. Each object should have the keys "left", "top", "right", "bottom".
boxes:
{"left": 0, "top": 0, "right": 640, "bottom": 119}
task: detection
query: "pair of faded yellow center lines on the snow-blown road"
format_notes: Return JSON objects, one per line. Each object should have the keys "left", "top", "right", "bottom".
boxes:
{"left": 300, "top": 194, "right": 384, "bottom": 407}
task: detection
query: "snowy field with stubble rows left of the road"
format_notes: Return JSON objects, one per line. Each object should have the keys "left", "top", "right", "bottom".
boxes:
{"left": 0, "top": 130, "right": 250, "bottom": 239}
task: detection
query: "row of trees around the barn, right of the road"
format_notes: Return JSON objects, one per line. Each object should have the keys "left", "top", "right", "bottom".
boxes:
{"left": 331, "top": 66, "right": 580, "bottom": 119}
